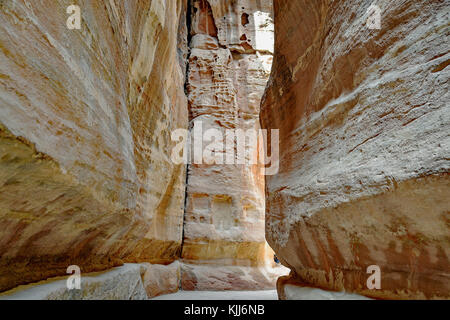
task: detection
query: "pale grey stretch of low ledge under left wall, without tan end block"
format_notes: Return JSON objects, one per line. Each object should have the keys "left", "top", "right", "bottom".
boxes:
{"left": 0, "top": 263, "right": 147, "bottom": 300}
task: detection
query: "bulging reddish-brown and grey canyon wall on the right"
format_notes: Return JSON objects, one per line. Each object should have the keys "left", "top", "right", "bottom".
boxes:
{"left": 261, "top": 0, "right": 450, "bottom": 298}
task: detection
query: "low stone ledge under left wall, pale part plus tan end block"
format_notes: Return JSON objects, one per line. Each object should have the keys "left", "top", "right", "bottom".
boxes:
{"left": 0, "top": 261, "right": 180, "bottom": 301}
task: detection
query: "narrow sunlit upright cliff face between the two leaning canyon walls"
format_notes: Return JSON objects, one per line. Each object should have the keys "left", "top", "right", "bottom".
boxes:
{"left": 182, "top": 0, "right": 284, "bottom": 290}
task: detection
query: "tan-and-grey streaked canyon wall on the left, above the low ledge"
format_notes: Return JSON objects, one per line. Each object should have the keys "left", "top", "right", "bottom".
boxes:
{"left": 0, "top": 0, "right": 188, "bottom": 291}
